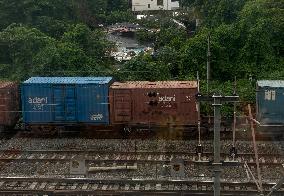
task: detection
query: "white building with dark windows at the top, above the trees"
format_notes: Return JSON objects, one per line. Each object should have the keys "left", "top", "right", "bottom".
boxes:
{"left": 132, "top": 0, "right": 179, "bottom": 12}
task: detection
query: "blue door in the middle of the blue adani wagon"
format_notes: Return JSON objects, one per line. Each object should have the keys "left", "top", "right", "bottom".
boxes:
{"left": 53, "top": 85, "right": 76, "bottom": 122}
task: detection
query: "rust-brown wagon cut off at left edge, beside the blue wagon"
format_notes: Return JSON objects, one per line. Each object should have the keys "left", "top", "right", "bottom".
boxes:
{"left": 0, "top": 82, "right": 19, "bottom": 131}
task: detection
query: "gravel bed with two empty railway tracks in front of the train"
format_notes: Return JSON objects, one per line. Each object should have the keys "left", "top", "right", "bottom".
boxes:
{"left": 0, "top": 136, "right": 284, "bottom": 195}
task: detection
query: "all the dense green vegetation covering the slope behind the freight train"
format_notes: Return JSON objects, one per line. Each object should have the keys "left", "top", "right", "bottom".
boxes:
{"left": 0, "top": 0, "right": 284, "bottom": 115}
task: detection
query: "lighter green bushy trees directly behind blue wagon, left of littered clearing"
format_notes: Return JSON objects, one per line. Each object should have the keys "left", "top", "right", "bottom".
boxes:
{"left": 0, "top": 25, "right": 114, "bottom": 80}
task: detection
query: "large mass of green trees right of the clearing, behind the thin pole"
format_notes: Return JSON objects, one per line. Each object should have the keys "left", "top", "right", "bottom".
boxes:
{"left": 180, "top": 0, "right": 284, "bottom": 81}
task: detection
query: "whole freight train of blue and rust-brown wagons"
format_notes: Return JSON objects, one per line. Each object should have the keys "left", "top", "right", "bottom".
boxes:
{"left": 0, "top": 77, "right": 284, "bottom": 137}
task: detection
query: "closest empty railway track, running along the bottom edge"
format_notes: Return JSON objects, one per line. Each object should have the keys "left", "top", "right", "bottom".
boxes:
{"left": 0, "top": 177, "right": 284, "bottom": 195}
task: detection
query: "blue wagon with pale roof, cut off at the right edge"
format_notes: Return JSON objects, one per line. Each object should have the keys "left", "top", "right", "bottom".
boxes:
{"left": 256, "top": 80, "right": 284, "bottom": 131}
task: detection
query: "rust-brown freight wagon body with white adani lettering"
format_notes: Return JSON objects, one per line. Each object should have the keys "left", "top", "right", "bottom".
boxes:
{"left": 110, "top": 81, "right": 197, "bottom": 125}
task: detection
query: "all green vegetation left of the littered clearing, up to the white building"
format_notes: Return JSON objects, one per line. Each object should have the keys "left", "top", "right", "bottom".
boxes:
{"left": 0, "top": 0, "right": 130, "bottom": 81}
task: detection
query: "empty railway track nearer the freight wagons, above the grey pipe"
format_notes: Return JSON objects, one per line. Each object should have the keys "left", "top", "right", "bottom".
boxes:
{"left": 0, "top": 150, "right": 284, "bottom": 165}
